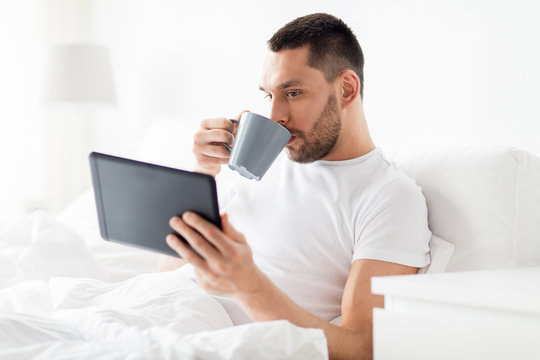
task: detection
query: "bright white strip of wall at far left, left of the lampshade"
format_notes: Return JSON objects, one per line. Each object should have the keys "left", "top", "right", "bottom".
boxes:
{"left": 0, "top": 0, "right": 42, "bottom": 219}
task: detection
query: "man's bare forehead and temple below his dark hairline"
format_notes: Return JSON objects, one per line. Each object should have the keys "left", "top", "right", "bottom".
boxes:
{"left": 260, "top": 46, "right": 324, "bottom": 91}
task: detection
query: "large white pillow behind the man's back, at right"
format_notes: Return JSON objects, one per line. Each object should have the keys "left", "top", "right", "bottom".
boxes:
{"left": 386, "top": 148, "right": 540, "bottom": 271}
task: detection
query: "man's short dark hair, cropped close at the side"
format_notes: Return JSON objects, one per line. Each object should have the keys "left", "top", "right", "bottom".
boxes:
{"left": 268, "top": 13, "right": 364, "bottom": 96}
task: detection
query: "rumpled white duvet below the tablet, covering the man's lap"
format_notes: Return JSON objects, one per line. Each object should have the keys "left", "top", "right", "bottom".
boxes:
{"left": 0, "top": 207, "right": 328, "bottom": 360}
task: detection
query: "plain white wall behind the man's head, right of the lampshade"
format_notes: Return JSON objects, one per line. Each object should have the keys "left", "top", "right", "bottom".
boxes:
{"left": 96, "top": 0, "right": 540, "bottom": 158}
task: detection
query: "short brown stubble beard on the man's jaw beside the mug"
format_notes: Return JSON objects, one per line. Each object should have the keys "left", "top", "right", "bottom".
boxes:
{"left": 287, "top": 94, "right": 341, "bottom": 164}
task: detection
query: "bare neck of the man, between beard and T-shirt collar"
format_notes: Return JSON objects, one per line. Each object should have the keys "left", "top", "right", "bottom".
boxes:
{"left": 324, "top": 98, "right": 375, "bottom": 161}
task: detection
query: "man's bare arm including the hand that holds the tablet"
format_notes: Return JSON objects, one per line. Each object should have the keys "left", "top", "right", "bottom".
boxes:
{"left": 167, "top": 213, "right": 417, "bottom": 359}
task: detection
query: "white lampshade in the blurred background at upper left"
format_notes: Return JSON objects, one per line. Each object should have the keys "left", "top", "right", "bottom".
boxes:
{"left": 43, "top": 44, "right": 116, "bottom": 105}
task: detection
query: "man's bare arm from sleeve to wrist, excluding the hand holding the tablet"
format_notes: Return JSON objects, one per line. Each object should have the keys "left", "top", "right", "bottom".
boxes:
{"left": 233, "top": 260, "right": 417, "bottom": 359}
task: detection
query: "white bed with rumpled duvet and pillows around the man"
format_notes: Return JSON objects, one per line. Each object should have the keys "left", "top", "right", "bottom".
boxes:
{"left": 0, "top": 119, "right": 540, "bottom": 359}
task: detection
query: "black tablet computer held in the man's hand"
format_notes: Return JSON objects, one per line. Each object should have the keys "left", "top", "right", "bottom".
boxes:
{"left": 89, "top": 152, "right": 221, "bottom": 257}
